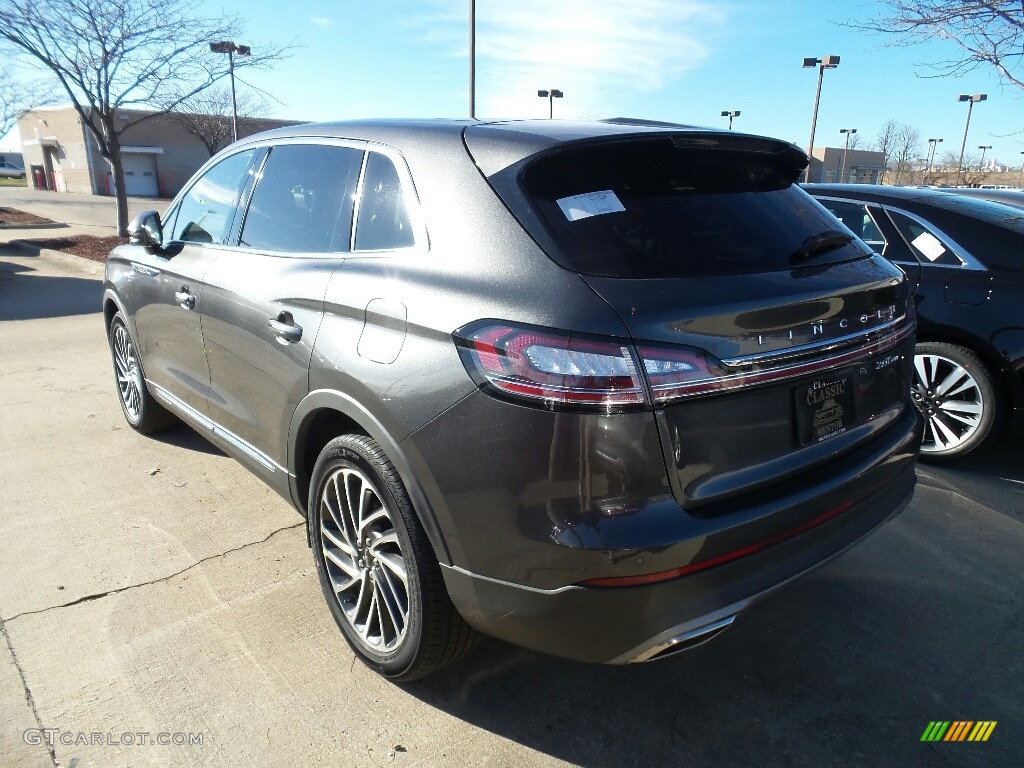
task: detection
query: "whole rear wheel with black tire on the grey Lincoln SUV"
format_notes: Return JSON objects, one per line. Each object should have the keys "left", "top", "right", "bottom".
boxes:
{"left": 308, "top": 434, "right": 476, "bottom": 682}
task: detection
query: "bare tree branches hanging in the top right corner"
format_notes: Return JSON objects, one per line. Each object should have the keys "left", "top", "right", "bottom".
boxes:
{"left": 850, "top": 0, "right": 1024, "bottom": 88}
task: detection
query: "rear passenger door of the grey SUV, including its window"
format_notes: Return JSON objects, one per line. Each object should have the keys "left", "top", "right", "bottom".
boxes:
{"left": 196, "top": 142, "right": 364, "bottom": 482}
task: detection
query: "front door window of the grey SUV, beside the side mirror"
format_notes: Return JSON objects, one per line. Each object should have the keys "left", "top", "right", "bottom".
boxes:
{"left": 171, "top": 150, "right": 256, "bottom": 243}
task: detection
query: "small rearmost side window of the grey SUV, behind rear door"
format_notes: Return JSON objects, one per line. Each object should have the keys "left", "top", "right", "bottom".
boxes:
{"left": 354, "top": 152, "right": 416, "bottom": 251}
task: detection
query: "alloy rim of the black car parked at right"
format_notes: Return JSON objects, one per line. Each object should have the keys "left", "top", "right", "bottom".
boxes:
{"left": 910, "top": 354, "right": 987, "bottom": 454}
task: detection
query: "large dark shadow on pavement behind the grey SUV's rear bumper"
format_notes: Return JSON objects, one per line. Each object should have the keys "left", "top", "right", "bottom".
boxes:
{"left": 407, "top": 489, "right": 1024, "bottom": 768}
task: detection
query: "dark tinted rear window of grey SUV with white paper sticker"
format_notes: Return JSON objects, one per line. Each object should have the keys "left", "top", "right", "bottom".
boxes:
{"left": 522, "top": 136, "right": 869, "bottom": 278}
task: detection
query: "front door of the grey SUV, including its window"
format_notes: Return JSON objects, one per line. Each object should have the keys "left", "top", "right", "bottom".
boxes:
{"left": 132, "top": 150, "right": 254, "bottom": 414}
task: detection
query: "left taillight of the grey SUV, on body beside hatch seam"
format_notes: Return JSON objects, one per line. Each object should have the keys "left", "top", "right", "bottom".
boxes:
{"left": 455, "top": 322, "right": 648, "bottom": 413}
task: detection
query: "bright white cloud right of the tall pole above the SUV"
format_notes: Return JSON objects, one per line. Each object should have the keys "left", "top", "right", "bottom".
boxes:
{"left": 417, "top": 0, "right": 726, "bottom": 117}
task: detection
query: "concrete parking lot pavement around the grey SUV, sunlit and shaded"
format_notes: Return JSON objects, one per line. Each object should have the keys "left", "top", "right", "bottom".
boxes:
{"left": 0, "top": 247, "right": 1024, "bottom": 768}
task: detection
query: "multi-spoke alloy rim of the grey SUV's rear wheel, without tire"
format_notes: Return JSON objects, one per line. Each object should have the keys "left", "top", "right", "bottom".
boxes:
{"left": 319, "top": 467, "right": 410, "bottom": 653}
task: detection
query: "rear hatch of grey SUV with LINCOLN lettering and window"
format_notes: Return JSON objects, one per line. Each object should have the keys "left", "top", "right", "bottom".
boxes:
{"left": 467, "top": 124, "right": 913, "bottom": 514}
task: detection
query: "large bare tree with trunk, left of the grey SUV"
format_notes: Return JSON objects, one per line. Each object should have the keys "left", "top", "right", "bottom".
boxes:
{"left": 0, "top": 0, "right": 285, "bottom": 237}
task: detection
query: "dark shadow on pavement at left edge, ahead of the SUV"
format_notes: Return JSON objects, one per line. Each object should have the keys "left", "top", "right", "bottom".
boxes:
{"left": 0, "top": 260, "right": 103, "bottom": 321}
